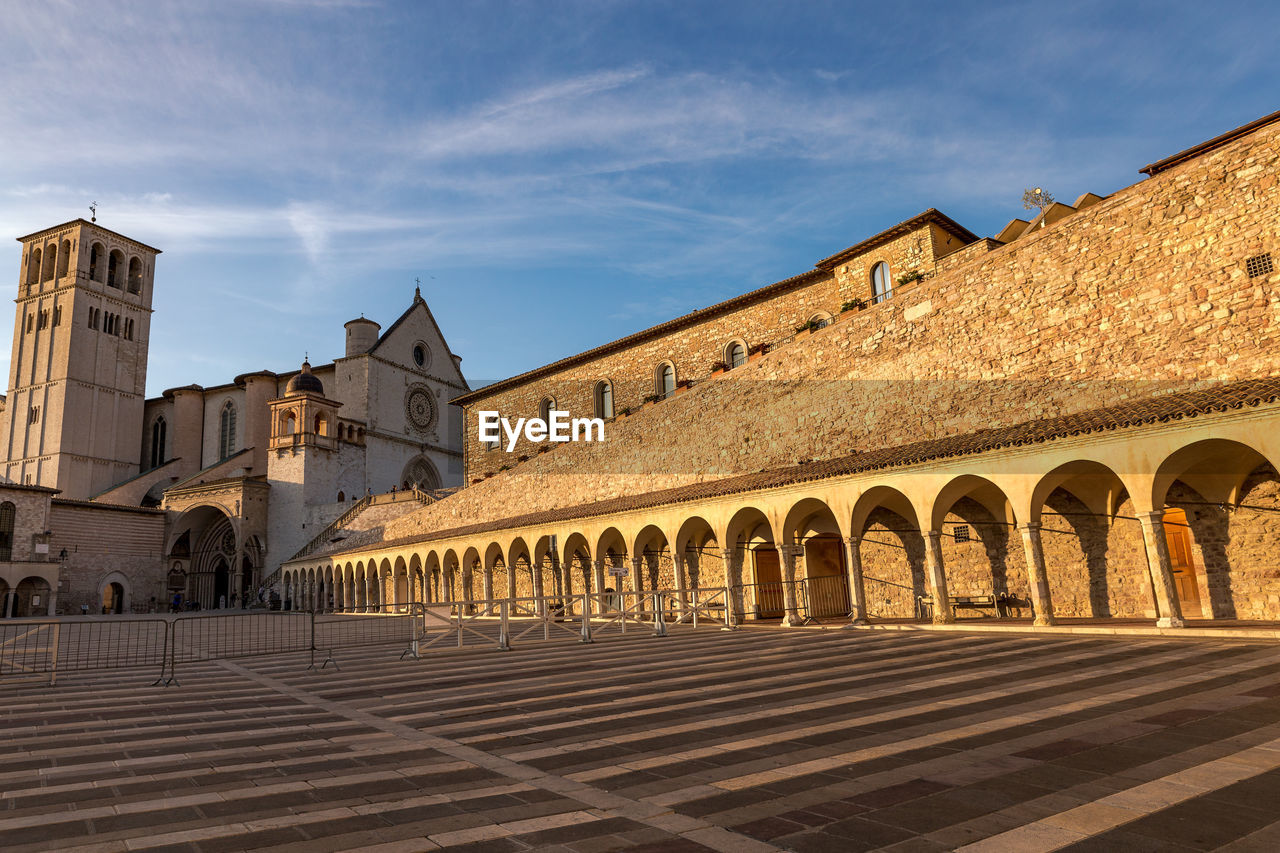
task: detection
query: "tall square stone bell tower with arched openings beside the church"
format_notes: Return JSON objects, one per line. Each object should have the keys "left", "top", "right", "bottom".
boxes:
{"left": 3, "top": 219, "right": 160, "bottom": 501}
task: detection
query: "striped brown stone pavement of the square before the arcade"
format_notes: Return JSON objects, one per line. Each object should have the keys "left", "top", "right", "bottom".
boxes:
{"left": 0, "top": 629, "right": 1280, "bottom": 853}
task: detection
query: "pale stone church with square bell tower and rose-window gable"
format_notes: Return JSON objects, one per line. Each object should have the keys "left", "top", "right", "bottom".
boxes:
{"left": 0, "top": 219, "right": 467, "bottom": 615}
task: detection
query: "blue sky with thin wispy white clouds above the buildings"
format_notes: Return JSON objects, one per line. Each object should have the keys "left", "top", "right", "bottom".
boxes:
{"left": 0, "top": 0, "right": 1280, "bottom": 394}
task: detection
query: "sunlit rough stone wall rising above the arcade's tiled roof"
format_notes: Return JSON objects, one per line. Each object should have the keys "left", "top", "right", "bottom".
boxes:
{"left": 387, "top": 114, "right": 1280, "bottom": 545}
